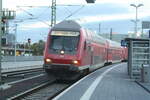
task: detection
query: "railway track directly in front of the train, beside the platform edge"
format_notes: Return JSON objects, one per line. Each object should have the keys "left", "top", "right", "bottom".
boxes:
{"left": 9, "top": 80, "right": 71, "bottom": 100}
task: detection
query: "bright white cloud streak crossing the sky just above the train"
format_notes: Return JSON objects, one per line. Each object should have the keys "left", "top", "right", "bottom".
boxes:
{"left": 17, "top": 9, "right": 150, "bottom": 30}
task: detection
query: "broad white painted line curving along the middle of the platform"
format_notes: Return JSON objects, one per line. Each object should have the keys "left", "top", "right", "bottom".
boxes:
{"left": 80, "top": 64, "right": 120, "bottom": 100}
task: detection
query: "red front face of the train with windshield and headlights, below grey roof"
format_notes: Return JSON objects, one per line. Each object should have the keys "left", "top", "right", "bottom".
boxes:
{"left": 44, "top": 21, "right": 84, "bottom": 79}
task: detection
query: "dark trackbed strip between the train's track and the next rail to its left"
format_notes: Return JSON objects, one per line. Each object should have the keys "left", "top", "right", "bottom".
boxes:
{"left": 0, "top": 74, "right": 51, "bottom": 100}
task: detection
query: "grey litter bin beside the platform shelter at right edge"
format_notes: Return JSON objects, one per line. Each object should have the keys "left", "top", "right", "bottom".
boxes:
{"left": 141, "top": 65, "right": 150, "bottom": 83}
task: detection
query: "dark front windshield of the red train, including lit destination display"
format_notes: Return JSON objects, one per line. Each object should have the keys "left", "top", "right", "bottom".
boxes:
{"left": 50, "top": 31, "right": 79, "bottom": 54}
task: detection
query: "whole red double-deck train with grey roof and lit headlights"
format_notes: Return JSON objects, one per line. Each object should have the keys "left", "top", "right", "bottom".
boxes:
{"left": 43, "top": 20, "right": 127, "bottom": 79}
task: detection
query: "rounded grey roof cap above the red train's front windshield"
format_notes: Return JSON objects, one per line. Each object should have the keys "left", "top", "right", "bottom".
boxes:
{"left": 52, "top": 20, "right": 81, "bottom": 31}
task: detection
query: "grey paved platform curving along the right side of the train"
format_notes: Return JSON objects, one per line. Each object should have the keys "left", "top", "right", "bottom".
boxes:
{"left": 53, "top": 63, "right": 150, "bottom": 100}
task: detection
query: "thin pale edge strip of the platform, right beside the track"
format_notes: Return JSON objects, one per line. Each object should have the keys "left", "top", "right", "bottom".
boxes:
{"left": 52, "top": 64, "right": 123, "bottom": 100}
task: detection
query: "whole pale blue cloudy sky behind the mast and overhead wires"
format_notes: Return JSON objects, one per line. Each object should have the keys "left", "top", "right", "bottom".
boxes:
{"left": 3, "top": 0, "right": 150, "bottom": 42}
